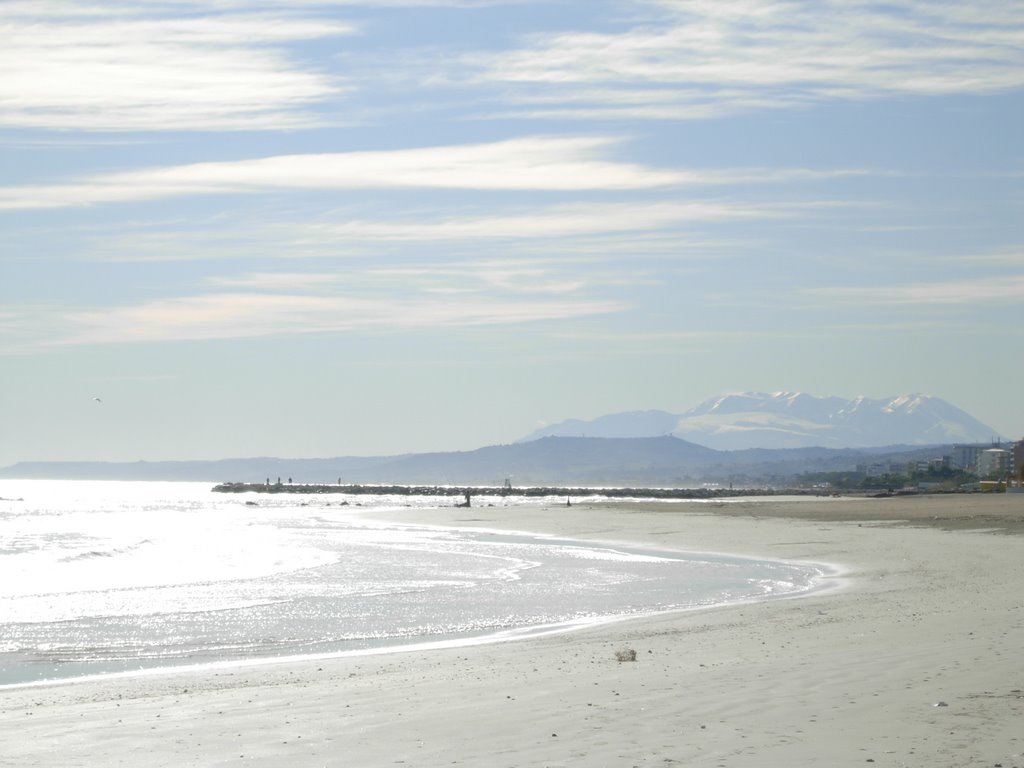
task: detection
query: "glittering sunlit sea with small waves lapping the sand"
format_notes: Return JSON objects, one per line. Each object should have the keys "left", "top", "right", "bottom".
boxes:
{"left": 0, "top": 480, "right": 823, "bottom": 686}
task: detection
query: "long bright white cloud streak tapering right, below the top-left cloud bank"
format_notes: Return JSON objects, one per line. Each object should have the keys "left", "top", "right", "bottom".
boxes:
{"left": 0, "top": 137, "right": 715, "bottom": 210}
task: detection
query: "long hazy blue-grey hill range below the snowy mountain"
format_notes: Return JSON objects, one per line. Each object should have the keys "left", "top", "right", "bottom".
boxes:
{"left": 0, "top": 436, "right": 966, "bottom": 487}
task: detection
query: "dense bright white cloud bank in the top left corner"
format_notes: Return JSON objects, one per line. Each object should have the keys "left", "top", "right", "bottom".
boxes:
{"left": 0, "top": 2, "right": 355, "bottom": 131}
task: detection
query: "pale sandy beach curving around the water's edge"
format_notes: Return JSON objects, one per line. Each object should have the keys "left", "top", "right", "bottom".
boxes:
{"left": 0, "top": 495, "right": 1024, "bottom": 768}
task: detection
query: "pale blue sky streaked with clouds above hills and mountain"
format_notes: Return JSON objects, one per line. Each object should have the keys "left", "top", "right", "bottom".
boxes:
{"left": 0, "top": 0, "right": 1024, "bottom": 466}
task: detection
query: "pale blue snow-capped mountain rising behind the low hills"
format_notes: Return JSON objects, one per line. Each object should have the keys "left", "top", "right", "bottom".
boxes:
{"left": 524, "top": 392, "right": 996, "bottom": 450}
